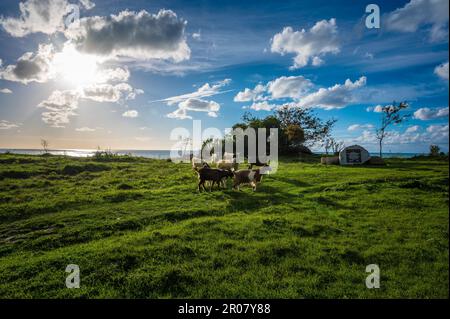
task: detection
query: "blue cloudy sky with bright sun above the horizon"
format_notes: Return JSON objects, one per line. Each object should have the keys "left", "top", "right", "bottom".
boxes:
{"left": 0, "top": 0, "right": 449, "bottom": 153}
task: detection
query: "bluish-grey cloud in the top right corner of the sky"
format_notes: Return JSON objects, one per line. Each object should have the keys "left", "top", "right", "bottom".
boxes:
{"left": 384, "top": 0, "right": 449, "bottom": 41}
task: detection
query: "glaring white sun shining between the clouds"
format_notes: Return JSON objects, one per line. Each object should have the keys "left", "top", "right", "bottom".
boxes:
{"left": 53, "top": 46, "right": 99, "bottom": 87}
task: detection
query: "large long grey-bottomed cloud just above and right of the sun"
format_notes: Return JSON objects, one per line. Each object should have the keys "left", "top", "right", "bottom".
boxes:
{"left": 64, "top": 10, "right": 190, "bottom": 62}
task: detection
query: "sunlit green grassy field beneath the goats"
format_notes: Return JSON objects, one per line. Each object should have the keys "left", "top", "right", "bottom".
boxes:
{"left": 0, "top": 154, "right": 449, "bottom": 298}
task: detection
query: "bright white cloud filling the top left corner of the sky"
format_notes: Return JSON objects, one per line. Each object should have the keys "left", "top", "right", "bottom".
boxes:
{"left": 0, "top": 0, "right": 71, "bottom": 37}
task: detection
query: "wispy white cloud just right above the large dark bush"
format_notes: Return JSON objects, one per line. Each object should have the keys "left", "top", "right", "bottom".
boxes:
{"left": 298, "top": 76, "right": 367, "bottom": 110}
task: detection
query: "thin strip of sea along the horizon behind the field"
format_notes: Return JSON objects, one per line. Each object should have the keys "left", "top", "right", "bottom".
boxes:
{"left": 0, "top": 148, "right": 423, "bottom": 159}
